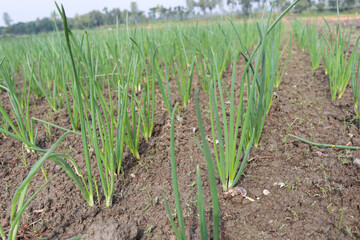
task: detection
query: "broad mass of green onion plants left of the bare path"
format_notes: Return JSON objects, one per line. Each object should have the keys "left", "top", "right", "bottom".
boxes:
{"left": 0, "top": 2, "right": 296, "bottom": 239}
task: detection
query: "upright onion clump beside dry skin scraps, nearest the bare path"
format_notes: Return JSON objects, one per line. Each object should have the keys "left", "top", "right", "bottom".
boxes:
{"left": 196, "top": 49, "right": 253, "bottom": 191}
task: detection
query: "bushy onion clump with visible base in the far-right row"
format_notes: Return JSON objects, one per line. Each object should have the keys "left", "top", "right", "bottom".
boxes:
{"left": 322, "top": 1, "right": 360, "bottom": 101}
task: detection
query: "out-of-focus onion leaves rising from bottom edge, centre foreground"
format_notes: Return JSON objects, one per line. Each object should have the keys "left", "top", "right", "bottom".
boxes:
{"left": 164, "top": 103, "right": 220, "bottom": 240}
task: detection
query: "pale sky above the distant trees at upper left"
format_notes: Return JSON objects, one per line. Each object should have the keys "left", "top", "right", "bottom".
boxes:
{"left": 0, "top": 0, "right": 186, "bottom": 26}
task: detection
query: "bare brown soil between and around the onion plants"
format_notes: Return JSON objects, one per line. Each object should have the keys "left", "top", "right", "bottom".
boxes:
{"left": 0, "top": 29, "right": 360, "bottom": 239}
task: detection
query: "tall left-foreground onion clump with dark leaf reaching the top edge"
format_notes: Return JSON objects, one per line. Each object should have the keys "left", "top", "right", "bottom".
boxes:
{"left": 57, "top": 2, "right": 129, "bottom": 207}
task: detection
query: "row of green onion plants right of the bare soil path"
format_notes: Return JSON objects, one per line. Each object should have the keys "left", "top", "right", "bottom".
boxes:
{"left": 292, "top": 2, "right": 360, "bottom": 126}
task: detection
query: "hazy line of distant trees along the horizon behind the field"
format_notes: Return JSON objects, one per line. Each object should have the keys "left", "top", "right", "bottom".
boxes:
{"left": 0, "top": 0, "right": 360, "bottom": 35}
